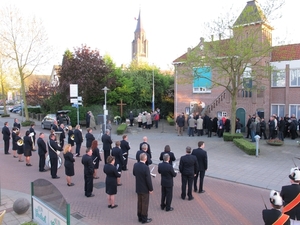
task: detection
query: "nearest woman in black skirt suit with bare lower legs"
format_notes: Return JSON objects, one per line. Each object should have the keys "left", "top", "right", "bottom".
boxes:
{"left": 103, "top": 155, "right": 121, "bottom": 209}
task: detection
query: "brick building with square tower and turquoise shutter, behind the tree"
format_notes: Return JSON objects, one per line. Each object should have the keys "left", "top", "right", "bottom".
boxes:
{"left": 173, "top": 0, "right": 300, "bottom": 125}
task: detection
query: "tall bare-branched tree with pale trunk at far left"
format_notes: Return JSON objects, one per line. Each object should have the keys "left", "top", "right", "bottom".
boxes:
{"left": 0, "top": 7, "right": 52, "bottom": 120}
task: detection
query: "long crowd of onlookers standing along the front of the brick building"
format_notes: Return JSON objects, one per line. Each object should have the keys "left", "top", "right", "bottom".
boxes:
{"left": 176, "top": 112, "right": 300, "bottom": 142}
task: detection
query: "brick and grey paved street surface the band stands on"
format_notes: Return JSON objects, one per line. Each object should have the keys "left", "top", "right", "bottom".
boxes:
{"left": 0, "top": 113, "right": 299, "bottom": 225}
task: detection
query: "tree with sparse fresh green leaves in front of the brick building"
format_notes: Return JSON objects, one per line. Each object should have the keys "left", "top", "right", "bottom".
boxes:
{"left": 184, "top": 0, "right": 282, "bottom": 133}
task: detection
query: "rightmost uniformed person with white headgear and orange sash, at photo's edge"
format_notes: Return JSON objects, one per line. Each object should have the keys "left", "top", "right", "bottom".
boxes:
{"left": 280, "top": 167, "right": 300, "bottom": 224}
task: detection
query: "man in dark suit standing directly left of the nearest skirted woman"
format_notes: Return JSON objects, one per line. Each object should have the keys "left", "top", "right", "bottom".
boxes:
{"left": 81, "top": 148, "right": 95, "bottom": 197}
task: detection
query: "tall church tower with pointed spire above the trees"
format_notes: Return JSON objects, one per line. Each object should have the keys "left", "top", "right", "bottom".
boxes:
{"left": 132, "top": 10, "right": 148, "bottom": 64}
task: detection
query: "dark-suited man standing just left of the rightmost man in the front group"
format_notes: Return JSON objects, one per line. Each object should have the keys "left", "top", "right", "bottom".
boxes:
{"left": 179, "top": 146, "right": 198, "bottom": 201}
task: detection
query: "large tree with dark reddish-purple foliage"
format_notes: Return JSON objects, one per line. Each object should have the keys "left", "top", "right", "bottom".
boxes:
{"left": 58, "top": 45, "right": 114, "bottom": 106}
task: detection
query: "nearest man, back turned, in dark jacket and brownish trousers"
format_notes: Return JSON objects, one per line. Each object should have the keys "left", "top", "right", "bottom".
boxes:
{"left": 133, "top": 153, "right": 153, "bottom": 223}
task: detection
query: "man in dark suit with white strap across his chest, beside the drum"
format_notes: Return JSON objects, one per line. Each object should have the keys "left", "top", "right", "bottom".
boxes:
{"left": 48, "top": 134, "right": 62, "bottom": 179}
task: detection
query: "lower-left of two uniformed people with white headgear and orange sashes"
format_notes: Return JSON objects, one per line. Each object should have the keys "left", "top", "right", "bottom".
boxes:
{"left": 262, "top": 190, "right": 290, "bottom": 225}
